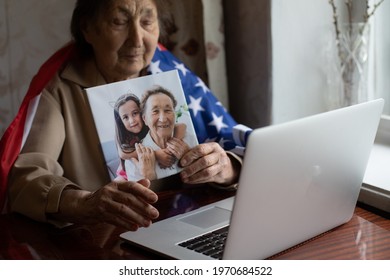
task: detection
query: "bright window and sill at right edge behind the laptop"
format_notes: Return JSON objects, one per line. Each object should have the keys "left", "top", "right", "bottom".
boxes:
{"left": 359, "top": 1, "right": 390, "bottom": 212}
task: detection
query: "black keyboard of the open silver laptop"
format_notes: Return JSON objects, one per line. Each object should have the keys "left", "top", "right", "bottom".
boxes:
{"left": 178, "top": 226, "right": 229, "bottom": 259}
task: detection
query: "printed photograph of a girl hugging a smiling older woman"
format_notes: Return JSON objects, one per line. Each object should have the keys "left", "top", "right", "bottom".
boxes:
{"left": 86, "top": 70, "right": 198, "bottom": 181}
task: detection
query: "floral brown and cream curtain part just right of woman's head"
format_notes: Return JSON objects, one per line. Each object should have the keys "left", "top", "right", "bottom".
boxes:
{"left": 166, "top": 0, "right": 229, "bottom": 108}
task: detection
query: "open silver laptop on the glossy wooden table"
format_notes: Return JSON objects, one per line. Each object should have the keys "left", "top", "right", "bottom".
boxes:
{"left": 120, "top": 99, "right": 384, "bottom": 259}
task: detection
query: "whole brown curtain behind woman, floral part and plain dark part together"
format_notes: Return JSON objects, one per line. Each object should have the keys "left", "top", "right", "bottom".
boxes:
{"left": 168, "top": 0, "right": 272, "bottom": 128}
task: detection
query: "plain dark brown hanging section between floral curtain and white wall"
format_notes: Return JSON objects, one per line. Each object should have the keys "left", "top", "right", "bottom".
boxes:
{"left": 223, "top": 0, "right": 272, "bottom": 128}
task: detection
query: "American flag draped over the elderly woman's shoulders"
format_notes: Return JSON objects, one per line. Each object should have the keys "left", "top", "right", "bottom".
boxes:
{"left": 0, "top": 43, "right": 251, "bottom": 212}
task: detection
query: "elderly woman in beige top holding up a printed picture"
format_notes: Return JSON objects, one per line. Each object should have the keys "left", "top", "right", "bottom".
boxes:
{"left": 2, "top": 0, "right": 247, "bottom": 230}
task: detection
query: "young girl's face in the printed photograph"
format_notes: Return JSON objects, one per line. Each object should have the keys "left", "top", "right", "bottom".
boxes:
{"left": 118, "top": 100, "right": 143, "bottom": 134}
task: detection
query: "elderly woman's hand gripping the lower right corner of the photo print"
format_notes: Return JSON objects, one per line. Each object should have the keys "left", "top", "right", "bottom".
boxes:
{"left": 180, "top": 142, "right": 240, "bottom": 185}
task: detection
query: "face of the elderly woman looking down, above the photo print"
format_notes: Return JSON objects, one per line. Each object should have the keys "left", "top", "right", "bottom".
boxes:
{"left": 83, "top": 0, "right": 160, "bottom": 82}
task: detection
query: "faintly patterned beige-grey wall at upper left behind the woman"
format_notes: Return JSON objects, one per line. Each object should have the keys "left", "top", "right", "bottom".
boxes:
{"left": 0, "top": 0, "right": 76, "bottom": 137}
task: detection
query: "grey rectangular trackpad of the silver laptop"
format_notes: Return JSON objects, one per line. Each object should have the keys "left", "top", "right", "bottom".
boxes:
{"left": 179, "top": 206, "right": 231, "bottom": 228}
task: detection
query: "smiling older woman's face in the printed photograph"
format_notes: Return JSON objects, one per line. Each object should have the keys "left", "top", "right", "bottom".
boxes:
{"left": 143, "top": 93, "right": 175, "bottom": 143}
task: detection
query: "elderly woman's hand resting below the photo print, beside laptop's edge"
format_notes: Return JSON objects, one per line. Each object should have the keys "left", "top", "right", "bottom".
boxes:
{"left": 55, "top": 179, "right": 159, "bottom": 231}
